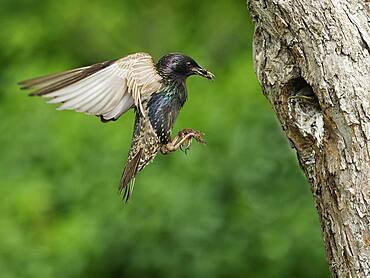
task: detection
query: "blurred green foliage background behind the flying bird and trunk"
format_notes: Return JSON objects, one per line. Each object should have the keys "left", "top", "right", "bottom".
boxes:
{"left": 0, "top": 0, "right": 329, "bottom": 278}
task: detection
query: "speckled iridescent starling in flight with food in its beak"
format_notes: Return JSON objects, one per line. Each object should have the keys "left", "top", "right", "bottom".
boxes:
{"left": 18, "top": 52, "right": 215, "bottom": 202}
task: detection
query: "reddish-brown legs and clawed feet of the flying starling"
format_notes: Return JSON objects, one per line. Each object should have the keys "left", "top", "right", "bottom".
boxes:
{"left": 161, "top": 128, "right": 206, "bottom": 154}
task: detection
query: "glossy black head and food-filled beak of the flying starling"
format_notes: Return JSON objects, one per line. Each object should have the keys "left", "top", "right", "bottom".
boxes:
{"left": 156, "top": 53, "right": 215, "bottom": 81}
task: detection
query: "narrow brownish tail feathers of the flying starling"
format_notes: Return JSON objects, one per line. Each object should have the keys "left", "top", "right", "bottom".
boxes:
{"left": 119, "top": 149, "right": 143, "bottom": 202}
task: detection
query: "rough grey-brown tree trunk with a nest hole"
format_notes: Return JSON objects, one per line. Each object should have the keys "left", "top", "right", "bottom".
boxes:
{"left": 248, "top": 0, "right": 370, "bottom": 277}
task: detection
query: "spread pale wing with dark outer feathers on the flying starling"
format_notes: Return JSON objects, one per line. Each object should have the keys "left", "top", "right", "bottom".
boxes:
{"left": 19, "top": 53, "right": 162, "bottom": 121}
